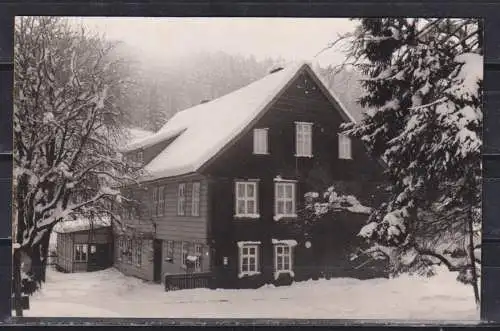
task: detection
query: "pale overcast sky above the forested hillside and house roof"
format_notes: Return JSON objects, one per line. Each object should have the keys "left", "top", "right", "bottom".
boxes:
{"left": 76, "top": 17, "right": 355, "bottom": 65}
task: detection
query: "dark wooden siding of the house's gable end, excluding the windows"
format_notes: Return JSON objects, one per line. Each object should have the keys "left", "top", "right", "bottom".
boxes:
{"left": 204, "top": 73, "right": 384, "bottom": 287}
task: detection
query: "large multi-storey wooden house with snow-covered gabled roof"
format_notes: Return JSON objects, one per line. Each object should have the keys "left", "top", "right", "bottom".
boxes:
{"left": 114, "top": 63, "right": 384, "bottom": 288}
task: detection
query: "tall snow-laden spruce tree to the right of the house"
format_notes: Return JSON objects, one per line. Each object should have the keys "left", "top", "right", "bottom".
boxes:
{"left": 344, "top": 18, "right": 482, "bottom": 302}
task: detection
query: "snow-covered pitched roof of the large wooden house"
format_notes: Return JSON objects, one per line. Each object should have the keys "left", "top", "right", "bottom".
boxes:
{"left": 126, "top": 62, "right": 355, "bottom": 180}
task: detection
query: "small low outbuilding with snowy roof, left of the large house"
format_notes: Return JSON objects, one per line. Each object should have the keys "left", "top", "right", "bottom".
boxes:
{"left": 54, "top": 218, "right": 113, "bottom": 272}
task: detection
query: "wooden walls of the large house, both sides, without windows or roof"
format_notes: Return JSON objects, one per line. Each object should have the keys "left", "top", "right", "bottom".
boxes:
{"left": 119, "top": 67, "right": 384, "bottom": 288}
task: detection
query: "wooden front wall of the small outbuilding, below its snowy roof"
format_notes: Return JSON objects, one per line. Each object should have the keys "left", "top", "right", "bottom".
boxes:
{"left": 56, "top": 227, "right": 113, "bottom": 272}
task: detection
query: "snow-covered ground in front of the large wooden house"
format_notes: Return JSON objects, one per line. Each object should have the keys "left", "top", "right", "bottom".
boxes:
{"left": 25, "top": 268, "right": 479, "bottom": 321}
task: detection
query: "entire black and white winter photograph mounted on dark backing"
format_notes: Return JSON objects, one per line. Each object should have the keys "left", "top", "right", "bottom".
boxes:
{"left": 12, "top": 16, "right": 483, "bottom": 321}
